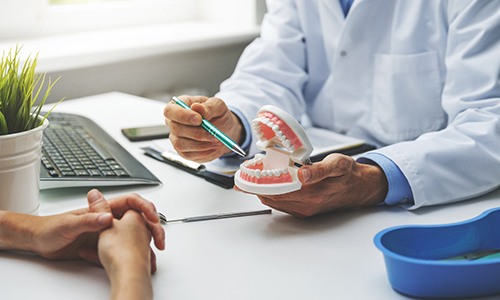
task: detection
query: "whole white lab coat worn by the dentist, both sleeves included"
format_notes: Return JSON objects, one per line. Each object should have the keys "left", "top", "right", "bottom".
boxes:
{"left": 217, "top": 0, "right": 500, "bottom": 208}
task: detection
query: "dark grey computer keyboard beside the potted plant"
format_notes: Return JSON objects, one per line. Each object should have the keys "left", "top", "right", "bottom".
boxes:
{"left": 40, "top": 112, "right": 161, "bottom": 189}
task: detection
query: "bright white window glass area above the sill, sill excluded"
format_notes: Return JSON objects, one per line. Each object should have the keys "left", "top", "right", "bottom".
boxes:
{"left": 0, "top": 0, "right": 199, "bottom": 40}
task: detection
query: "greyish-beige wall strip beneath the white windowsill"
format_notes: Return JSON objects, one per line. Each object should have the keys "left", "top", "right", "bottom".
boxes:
{"left": 47, "top": 41, "right": 250, "bottom": 102}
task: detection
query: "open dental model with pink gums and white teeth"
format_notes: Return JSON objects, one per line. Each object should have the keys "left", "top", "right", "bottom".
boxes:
{"left": 234, "top": 105, "right": 313, "bottom": 195}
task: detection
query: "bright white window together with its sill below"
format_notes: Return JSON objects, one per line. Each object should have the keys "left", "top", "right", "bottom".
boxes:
{"left": 0, "top": 0, "right": 264, "bottom": 72}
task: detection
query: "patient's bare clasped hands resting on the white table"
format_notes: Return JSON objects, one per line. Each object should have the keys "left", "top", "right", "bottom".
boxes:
{"left": 26, "top": 189, "right": 165, "bottom": 272}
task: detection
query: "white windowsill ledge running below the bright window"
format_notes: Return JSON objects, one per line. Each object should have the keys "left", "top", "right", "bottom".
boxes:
{"left": 0, "top": 22, "right": 259, "bottom": 72}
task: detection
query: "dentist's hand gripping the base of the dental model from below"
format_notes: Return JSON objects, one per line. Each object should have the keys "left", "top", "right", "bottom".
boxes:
{"left": 248, "top": 154, "right": 388, "bottom": 218}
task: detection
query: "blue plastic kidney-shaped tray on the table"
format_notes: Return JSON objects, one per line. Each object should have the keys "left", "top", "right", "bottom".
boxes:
{"left": 374, "top": 208, "right": 500, "bottom": 298}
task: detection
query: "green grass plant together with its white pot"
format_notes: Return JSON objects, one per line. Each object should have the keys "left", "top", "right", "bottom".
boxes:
{"left": 0, "top": 47, "right": 62, "bottom": 214}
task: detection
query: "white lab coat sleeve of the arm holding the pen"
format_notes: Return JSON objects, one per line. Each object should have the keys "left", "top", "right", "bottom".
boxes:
{"left": 216, "top": 0, "right": 307, "bottom": 154}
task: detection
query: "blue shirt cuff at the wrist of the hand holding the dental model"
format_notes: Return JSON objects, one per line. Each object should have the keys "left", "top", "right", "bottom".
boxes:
{"left": 357, "top": 152, "right": 414, "bottom": 206}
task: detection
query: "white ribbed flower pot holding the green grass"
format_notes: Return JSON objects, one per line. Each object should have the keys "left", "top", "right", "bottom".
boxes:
{"left": 0, "top": 120, "right": 49, "bottom": 214}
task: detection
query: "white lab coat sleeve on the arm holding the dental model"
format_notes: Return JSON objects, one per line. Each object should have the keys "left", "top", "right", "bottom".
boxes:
{"left": 377, "top": 1, "right": 500, "bottom": 209}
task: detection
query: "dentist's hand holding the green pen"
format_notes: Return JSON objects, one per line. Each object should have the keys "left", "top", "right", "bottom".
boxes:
{"left": 163, "top": 96, "right": 244, "bottom": 162}
